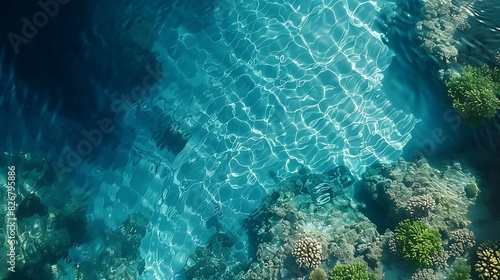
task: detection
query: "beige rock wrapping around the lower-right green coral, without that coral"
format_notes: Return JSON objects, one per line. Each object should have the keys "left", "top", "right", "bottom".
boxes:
{"left": 363, "top": 159, "right": 486, "bottom": 279}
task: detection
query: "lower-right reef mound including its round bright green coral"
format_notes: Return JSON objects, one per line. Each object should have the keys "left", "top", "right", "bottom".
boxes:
{"left": 363, "top": 159, "right": 492, "bottom": 279}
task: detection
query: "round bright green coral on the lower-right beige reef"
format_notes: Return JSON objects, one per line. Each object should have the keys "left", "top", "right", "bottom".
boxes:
{"left": 394, "top": 220, "right": 443, "bottom": 268}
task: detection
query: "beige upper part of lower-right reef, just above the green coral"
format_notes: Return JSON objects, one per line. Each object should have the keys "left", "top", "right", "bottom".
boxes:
{"left": 363, "top": 159, "right": 477, "bottom": 233}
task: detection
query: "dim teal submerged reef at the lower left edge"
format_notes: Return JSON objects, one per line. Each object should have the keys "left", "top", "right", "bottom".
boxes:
{"left": 0, "top": 153, "right": 86, "bottom": 279}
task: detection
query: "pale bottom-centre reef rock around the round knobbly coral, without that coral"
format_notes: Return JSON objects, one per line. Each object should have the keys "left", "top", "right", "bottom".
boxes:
{"left": 237, "top": 172, "right": 382, "bottom": 279}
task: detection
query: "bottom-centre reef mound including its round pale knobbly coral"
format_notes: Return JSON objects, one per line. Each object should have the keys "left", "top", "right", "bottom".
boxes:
{"left": 186, "top": 167, "right": 384, "bottom": 279}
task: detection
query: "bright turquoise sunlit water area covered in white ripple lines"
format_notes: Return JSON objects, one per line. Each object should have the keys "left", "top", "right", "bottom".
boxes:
{"left": 108, "top": 0, "right": 418, "bottom": 279}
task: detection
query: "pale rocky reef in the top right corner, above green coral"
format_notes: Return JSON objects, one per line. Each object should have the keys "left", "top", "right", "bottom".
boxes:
{"left": 390, "top": 0, "right": 500, "bottom": 77}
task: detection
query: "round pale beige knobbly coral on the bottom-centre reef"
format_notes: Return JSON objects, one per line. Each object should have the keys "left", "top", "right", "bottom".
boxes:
{"left": 292, "top": 237, "right": 323, "bottom": 267}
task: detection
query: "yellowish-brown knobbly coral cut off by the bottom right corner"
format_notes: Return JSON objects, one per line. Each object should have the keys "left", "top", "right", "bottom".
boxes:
{"left": 474, "top": 241, "right": 500, "bottom": 280}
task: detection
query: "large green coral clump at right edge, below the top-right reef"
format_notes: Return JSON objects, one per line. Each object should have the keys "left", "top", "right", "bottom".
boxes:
{"left": 447, "top": 65, "right": 500, "bottom": 126}
